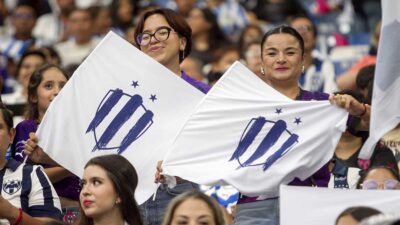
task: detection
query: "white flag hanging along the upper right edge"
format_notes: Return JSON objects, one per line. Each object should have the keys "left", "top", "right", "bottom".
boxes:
{"left": 359, "top": 0, "right": 400, "bottom": 159}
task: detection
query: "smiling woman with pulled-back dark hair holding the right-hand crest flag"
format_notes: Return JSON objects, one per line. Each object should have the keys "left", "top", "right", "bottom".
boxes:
{"left": 235, "top": 25, "right": 370, "bottom": 225}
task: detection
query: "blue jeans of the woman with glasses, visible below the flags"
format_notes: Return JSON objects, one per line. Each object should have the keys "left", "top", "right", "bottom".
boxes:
{"left": 140, "top": 181, "right": 198, "bottom": 225}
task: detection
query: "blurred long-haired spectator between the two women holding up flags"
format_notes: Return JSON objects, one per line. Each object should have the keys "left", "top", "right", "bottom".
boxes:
{"left": 187, "top": 8, "right": 228, "bottom": 65}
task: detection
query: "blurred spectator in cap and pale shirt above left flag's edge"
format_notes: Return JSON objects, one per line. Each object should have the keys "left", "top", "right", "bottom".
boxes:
{"left": 55, "top": 9, "right": 98, "bottom": 67}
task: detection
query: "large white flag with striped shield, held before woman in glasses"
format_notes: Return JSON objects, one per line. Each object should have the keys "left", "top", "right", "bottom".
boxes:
{"left": 37, "top": 33, "right": 204, "bottom": 203}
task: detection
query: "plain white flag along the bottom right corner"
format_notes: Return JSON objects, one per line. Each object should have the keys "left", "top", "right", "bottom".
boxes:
{"left": 279, "top": 185, "right": 400, "bottom": 225}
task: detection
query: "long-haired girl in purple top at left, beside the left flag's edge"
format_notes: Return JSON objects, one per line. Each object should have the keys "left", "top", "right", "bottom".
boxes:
{"left": 12, "top": 64, "right": 79, "bottom": 223}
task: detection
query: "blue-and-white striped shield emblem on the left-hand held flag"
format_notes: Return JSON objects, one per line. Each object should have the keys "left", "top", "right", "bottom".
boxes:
{"left": 86, "top": 89, "right": 154, "bottom": 154}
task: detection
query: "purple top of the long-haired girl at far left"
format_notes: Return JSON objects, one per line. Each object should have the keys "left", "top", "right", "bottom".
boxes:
{"left": 12, "top": 120, "right": 79, "bottom": 201}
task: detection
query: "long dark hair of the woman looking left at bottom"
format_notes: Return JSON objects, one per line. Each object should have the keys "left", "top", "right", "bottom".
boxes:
{"left": 78, "top": 155, "right": 143, "bottom": 225}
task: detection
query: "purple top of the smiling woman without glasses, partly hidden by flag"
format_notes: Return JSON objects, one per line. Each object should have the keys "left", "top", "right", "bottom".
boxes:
{"left": 238, "top": 89, "right": 330, "bottom": 204}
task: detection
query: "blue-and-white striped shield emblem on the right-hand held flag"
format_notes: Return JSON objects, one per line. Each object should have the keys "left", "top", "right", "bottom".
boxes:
{"left": 229, "top": 116, "right": 299, "bottom": 171}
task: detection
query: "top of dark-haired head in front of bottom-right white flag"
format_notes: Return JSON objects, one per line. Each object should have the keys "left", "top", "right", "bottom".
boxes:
{"left": 335, "top": 206, "right": 381, "bottom": 225}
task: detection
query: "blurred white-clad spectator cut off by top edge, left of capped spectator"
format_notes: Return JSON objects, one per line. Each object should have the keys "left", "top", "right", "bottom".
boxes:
{"left": 33, "top": 0, "right": 76, "bottom": 45}
